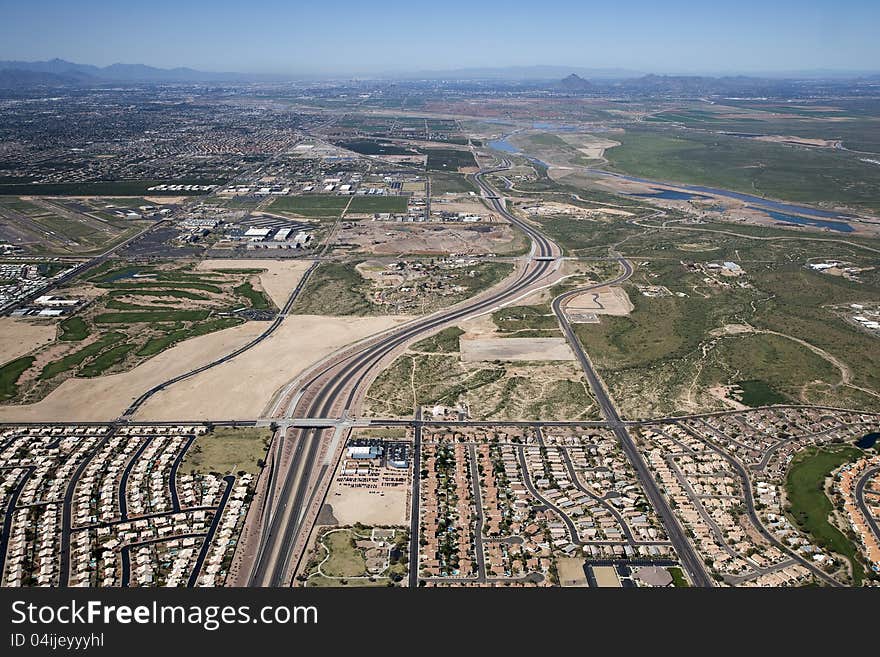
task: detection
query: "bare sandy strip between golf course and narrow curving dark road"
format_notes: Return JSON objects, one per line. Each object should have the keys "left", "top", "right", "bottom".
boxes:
{"left": 0, "top": 322, "right": 266, "bottom": 422}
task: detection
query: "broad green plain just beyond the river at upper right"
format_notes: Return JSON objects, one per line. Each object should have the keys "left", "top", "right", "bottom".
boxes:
{"left": 605, "top": 129, "right": 880, "bottom": 214}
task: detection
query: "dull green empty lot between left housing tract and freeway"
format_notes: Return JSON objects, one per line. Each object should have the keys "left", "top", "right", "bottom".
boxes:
{"left": 180, "top": 427, "right": 272, "bottom": 476}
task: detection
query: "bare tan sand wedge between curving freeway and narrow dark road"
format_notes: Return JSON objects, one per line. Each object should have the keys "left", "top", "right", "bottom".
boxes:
{"left": 134, "top": 315, "right": 410, "bottom": 420}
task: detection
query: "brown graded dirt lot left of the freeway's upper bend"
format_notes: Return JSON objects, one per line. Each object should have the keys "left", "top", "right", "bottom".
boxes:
{"left": 336, "top": 221, "right": 522, "bottom": 255}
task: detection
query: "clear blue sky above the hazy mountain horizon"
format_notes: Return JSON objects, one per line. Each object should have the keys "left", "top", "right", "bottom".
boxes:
{"left": 0, "top": 0, "right": 880, "bottom": 74}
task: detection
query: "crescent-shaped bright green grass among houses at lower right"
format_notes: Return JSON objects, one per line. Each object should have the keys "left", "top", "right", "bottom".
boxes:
{"left": 785, "top": 446, "right": 865, "bottom": 586}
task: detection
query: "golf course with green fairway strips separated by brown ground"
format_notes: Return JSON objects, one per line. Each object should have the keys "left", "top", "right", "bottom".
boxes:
{"left": 0, "top": 261, "right": 280, "bottom": 404}
